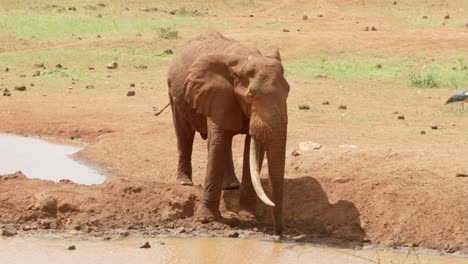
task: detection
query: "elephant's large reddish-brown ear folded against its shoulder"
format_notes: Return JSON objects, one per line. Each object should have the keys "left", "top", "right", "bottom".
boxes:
{"left": 184, "top": 54, "right": 246, "bottom": 132}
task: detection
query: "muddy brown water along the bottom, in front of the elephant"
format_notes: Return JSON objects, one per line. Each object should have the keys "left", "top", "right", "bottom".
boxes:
{"left": 0, "top": 237, "right": 468, "bottom": 264}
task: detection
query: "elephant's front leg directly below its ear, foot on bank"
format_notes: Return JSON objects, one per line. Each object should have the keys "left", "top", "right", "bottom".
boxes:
{"left": 196, "top": 118, "right": 233, "bottom": 222}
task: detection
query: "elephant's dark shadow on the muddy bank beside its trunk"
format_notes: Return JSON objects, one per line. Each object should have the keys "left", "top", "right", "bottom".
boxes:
{"left": 223, "top": 176, "right": 365, "bottom": 241}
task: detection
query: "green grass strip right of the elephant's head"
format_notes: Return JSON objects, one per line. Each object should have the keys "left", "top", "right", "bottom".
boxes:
{"left": 285, "top": 57, "right": 468, "bottom": 88}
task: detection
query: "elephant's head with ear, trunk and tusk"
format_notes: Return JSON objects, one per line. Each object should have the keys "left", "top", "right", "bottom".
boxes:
{"left": 185, "top": 51, "right": 289, "bottom": 233}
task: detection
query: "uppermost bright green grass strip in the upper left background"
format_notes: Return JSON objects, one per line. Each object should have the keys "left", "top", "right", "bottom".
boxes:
{"left": 0, "top": 12, "right": 223, "bottom": 41}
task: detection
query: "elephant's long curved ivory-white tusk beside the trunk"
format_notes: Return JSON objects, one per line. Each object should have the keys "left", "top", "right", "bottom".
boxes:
{"left": 249, "top": 137, "right": 275, "bottom": 206}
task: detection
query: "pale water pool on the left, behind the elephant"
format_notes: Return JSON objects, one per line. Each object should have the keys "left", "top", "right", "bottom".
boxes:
{"left": 0, "top": 134, "right": 105, "bottom": 184}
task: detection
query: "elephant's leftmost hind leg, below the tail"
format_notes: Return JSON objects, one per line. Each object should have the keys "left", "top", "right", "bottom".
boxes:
{"left": 171, "top": 102, "right": 195, "bottom": 185}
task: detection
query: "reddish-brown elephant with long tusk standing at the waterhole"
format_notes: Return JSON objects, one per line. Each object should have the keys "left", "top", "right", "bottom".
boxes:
{"left": 168, "top": 32, "right": 289, "bottom": 234}
